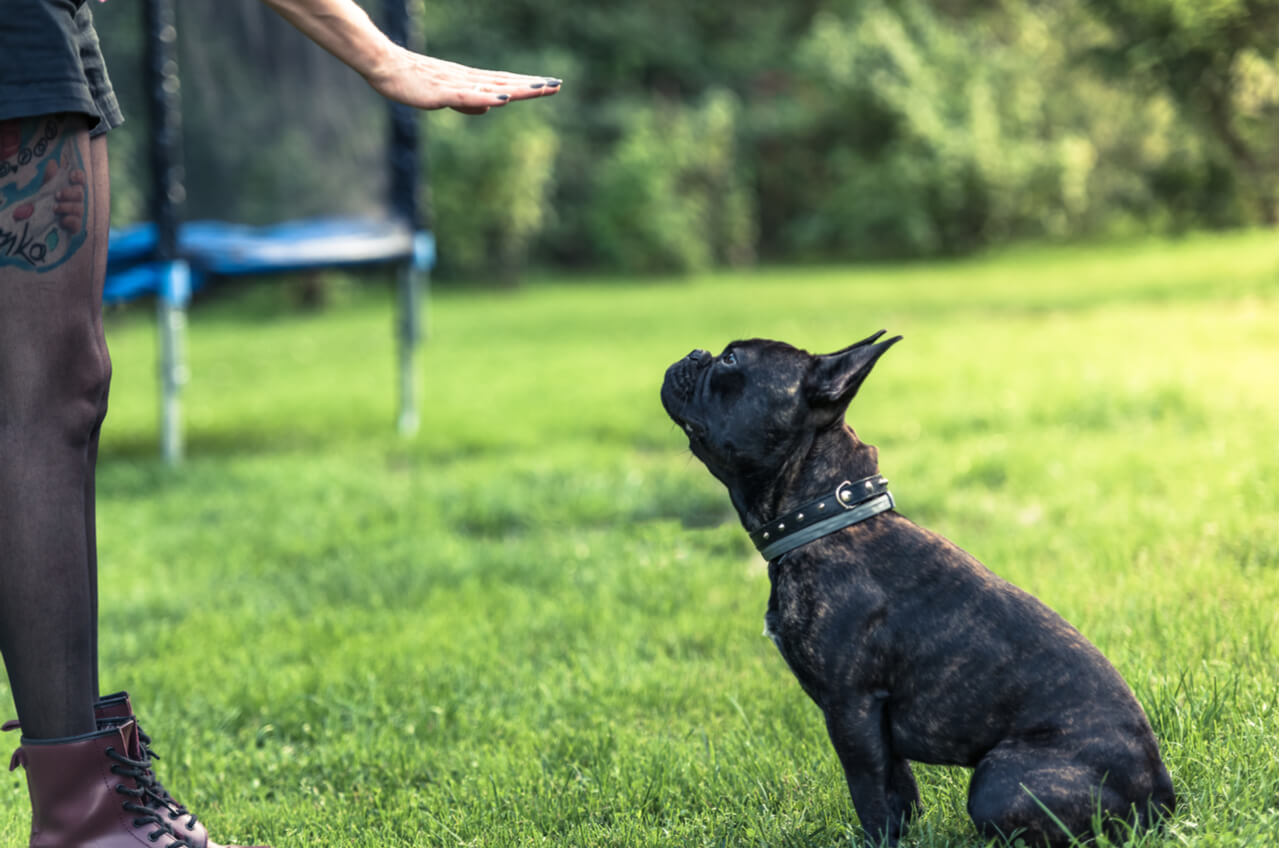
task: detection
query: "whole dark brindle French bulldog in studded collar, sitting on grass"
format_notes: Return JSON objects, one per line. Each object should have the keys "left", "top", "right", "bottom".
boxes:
{"left": 662, "top": 330, "right": 1175, "bottom": 847}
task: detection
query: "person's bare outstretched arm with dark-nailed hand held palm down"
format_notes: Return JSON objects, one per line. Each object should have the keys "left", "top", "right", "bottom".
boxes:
{"left": 262, "top": 0, "right": 561, "bottom": 114}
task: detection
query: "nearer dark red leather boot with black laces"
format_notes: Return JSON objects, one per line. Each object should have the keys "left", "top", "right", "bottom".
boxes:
{"left": 9, "top": 721, "right": 188, "bottom": 848}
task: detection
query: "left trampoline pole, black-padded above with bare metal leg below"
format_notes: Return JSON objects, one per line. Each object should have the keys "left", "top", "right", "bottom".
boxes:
{"left": 142, "top": 0, "right": 191, "bottom": 464}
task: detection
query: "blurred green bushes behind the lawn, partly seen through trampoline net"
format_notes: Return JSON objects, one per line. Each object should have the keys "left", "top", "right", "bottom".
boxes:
{"left": 96, "top": 0, "right": 1277, "bottom": 282}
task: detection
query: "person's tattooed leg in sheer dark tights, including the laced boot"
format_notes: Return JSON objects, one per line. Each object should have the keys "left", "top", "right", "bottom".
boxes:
{"left": 0, "top": 115, "right": 264, "bottom": 848}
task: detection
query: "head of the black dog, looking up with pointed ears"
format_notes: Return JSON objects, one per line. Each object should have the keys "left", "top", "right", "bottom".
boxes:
{"left": 662, "top": 330, "right": 902, "bottom": 501}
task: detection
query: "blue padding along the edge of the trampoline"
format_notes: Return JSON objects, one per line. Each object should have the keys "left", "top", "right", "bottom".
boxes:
{"left": 104, "top": 218, "right": 435, "bottom": 301}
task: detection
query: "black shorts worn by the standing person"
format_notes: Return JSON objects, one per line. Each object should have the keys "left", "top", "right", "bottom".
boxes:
{"left": 0, "top": 0, "right": 124, "bottom": 136}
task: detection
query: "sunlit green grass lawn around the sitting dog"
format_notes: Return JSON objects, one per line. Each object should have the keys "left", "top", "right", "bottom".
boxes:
{"left": 0, "top": 232, "right": 1280, "bottom": 848}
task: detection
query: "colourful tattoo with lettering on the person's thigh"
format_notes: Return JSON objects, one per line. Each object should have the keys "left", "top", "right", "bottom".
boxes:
{"left": 0, "top": 117, "right": 88, "bottom": 273}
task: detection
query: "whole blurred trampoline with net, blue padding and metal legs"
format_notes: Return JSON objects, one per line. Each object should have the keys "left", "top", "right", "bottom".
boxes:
{"left": 99, "top": 0, "right": 435, "bottom": 464}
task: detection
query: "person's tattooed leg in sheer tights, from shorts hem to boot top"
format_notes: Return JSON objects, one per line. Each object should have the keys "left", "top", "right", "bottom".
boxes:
{"left": 0, "top": 115, "right": 110, "bottom": 739}
